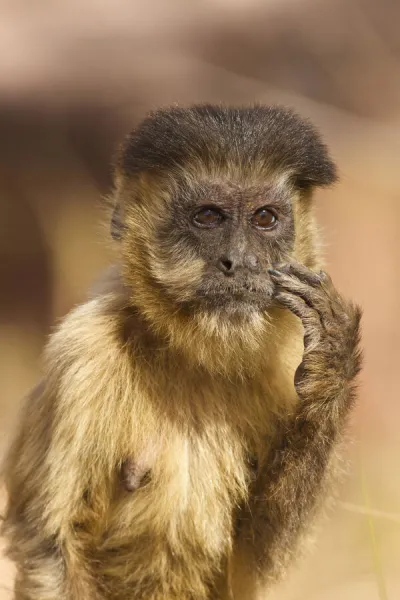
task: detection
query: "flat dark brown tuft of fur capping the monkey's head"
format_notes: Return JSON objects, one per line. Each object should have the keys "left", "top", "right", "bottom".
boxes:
{"left": 118, "top": 105, "right": 337, "bottom": 188}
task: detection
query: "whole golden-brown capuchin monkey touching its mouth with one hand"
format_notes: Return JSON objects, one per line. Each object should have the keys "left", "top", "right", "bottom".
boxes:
{"left": 3, "top": 105, "right": 361, "bottom": 600}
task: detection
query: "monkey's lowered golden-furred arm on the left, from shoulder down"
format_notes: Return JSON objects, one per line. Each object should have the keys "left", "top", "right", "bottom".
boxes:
{"left": 3, "top": 301, "right": 122, "bottom": 600}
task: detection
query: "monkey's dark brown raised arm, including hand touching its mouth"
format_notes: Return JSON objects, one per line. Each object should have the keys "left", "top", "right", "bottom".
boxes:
{"left": 231, "top": 264, "right": 361, "bottom": 592}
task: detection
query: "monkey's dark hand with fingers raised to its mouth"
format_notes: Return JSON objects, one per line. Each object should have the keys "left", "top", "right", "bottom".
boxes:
{"left": 269, "top": 263, "right": 361, "bottom": 408}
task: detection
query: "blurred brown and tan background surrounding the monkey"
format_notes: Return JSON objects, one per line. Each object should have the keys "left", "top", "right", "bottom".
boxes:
{"left": 0, "top": 0, "right": 400, "bottom": 600}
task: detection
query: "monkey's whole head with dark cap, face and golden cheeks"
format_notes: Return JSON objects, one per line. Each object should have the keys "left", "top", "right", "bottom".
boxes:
{"left": 112, "top": 105, "right": 336, "bottom": 368}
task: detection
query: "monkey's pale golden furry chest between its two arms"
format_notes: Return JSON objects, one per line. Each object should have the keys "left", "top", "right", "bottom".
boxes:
{"left": 95, "top": 375, "right": 276, "bottom": 564}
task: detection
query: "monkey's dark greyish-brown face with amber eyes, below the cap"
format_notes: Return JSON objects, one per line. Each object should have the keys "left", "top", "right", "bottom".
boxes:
{"left": 142, "top": 177, "right": 294, "bottom": 315}
